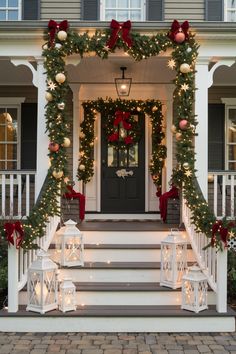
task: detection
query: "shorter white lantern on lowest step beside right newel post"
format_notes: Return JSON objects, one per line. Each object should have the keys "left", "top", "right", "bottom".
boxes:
{"left": 181, "top": 266, "right": 208, "bottom": 313}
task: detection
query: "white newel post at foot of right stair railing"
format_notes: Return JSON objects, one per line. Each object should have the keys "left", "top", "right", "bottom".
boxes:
{"left": 216, "top": 250, "right": 227, "bottom": 312}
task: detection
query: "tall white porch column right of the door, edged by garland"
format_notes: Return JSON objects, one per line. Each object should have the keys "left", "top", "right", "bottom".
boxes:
{"left": 195, "top": 59, "right": 209, "bottom": 199}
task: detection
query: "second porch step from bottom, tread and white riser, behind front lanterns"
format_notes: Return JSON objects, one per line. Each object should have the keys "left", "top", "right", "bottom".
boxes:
{"left": 20, "top": 282, "right": 216, "bottom": 306}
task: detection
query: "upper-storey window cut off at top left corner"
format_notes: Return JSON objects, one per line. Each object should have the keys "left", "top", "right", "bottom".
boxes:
{"left": 0, "top": 0, "right": 21, "bottom": 21}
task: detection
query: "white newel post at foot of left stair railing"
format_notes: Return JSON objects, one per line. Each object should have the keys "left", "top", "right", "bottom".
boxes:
{"left": 8, "top": 245, "right": 19, "bottom": 312}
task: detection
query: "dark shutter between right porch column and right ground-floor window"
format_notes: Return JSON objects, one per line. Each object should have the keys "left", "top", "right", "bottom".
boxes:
{"left": 208, "top": 104, "right": 225, "bottom": 170}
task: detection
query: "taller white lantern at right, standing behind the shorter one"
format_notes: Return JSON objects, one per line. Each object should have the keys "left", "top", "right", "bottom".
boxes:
{"left": 160, "top": 229, "right": 187, "bottom": 289}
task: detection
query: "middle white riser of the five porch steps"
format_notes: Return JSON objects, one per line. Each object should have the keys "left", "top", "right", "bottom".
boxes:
{"left": 59, "top": 268, "right": 175, "bottom": 283}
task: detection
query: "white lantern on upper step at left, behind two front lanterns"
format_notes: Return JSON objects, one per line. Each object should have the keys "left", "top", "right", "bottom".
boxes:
{"left": 57, "top": 220, "right": 84, "bottom": 267}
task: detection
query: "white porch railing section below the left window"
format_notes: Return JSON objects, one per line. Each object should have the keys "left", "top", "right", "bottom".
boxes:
{"left": 0, "top": 170, "right": 36, "bottom": 219}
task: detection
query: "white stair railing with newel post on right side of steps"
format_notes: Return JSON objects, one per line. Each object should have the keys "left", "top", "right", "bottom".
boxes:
{"left": 182, "top": 199, "right": 227, "bottom": 312}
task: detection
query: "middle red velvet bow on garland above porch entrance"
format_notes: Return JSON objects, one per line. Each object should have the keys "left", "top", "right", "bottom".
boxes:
{"left": 107, "top": 20, "right": 132, "bottom": 49}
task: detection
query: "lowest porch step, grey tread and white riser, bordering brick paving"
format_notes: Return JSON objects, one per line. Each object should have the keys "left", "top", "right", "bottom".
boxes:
{"left": 0, "top": 306, "right": 235, "bottom": 333}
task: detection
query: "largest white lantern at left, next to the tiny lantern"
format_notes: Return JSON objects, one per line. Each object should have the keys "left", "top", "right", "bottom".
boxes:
{"left": 26, "top": 250, "right": 58, "bottom": 313}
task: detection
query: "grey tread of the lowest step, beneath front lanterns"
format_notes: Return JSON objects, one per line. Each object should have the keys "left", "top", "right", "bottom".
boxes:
{"left": 0, "top": 305, "right": 236, "bottom": 318}
